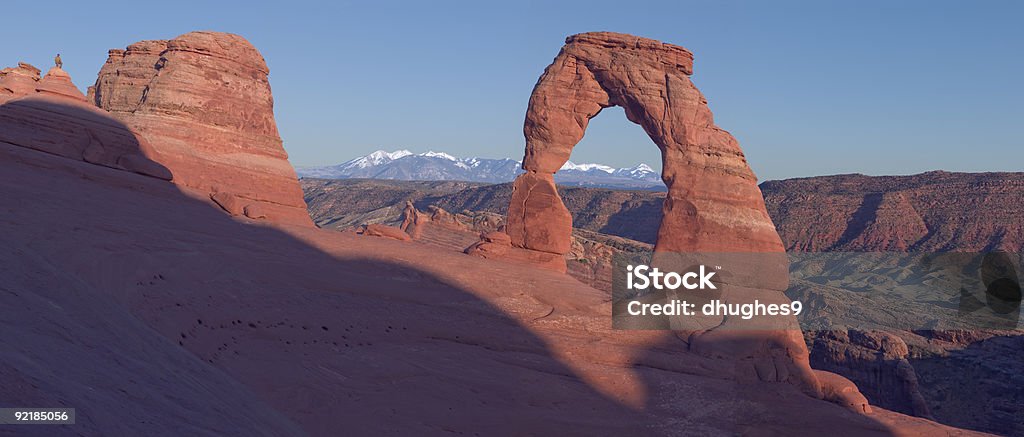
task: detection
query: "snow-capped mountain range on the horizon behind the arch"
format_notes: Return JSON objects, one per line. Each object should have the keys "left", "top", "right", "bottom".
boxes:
{"left": 298, "top": 150, "right": 664, "bottom": 188}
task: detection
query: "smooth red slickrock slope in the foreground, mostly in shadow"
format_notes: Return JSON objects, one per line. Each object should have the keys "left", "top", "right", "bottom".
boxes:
{"left": 0, "top": 144, "right": 983, "bottom": 436}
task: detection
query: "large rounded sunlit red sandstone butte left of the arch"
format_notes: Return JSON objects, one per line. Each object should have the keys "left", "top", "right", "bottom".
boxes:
{"left": 89, "top": 32, "right": 311, "bottom": 225}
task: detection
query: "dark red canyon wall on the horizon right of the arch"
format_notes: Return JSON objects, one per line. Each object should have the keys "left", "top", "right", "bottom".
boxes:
{"left": 761, "top": 172, "right": 1024, "bottom": 252}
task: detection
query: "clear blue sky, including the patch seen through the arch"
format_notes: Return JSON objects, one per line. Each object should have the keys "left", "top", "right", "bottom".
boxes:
{"left": 0, "top": 0, "right": 1024, "bottom": 179}
